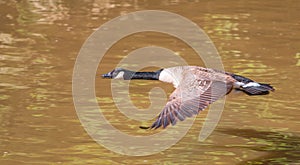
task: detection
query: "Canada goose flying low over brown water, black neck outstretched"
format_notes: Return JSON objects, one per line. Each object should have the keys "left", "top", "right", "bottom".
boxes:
{"left": 102, "top": 66, "right": 274, "bottom": 129}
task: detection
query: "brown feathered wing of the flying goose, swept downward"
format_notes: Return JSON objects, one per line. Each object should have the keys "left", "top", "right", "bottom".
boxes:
{"left": 150, "top": 80, "right": 233, "bottom": 129}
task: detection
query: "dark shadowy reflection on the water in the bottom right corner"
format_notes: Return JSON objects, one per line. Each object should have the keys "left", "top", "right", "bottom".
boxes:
{"left": 220, "top": 129, "right": 300, "bottom": 164}
